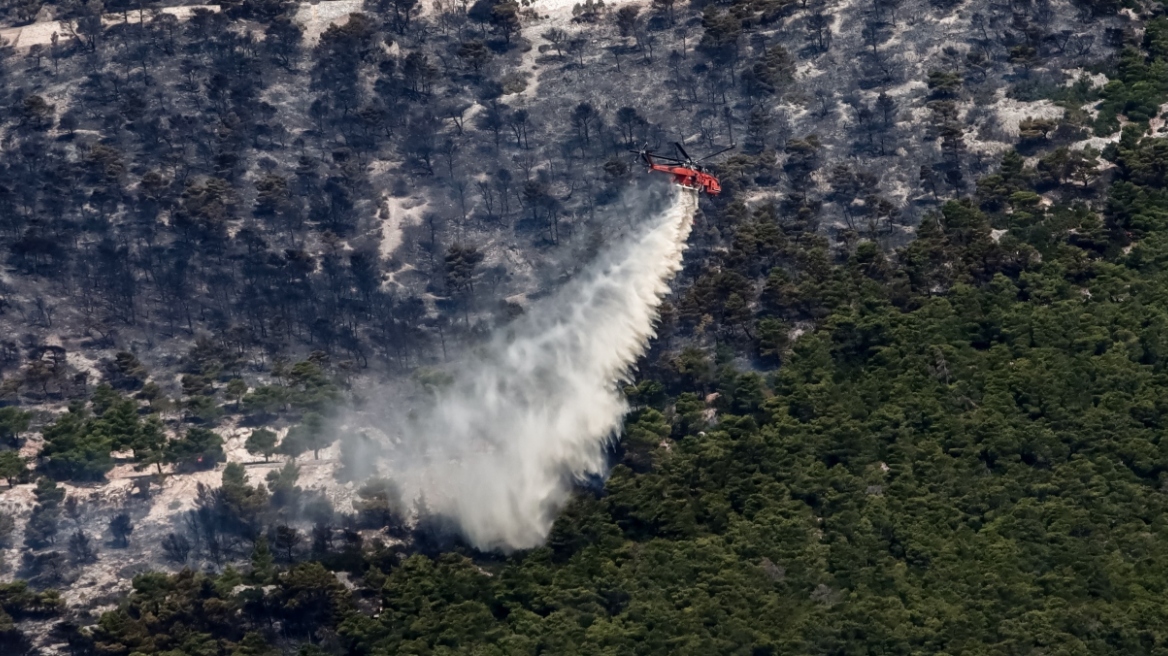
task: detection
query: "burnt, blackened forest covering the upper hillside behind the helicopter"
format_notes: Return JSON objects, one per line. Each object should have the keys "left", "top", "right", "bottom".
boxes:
{"left": 0, "top": 0, "right": 1124, "bottom": 398}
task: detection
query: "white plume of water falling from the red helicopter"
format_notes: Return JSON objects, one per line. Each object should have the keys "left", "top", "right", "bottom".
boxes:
{"left": 364, "top": 188, "right": 697, "bottom": 550}
